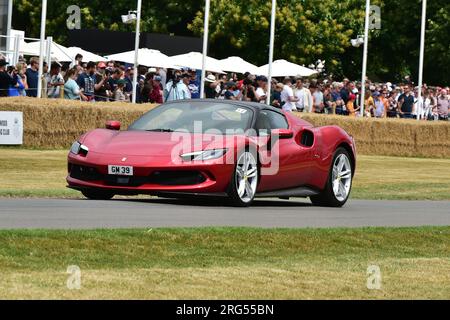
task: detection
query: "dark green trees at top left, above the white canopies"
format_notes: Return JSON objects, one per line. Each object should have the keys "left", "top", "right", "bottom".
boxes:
{"left": 13, "top": 0, "right": 202, "bottom": 44}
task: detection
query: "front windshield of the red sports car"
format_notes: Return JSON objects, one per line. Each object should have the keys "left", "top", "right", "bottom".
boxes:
{"left": 128, "top": 101, "right": 253, "bottom": 134}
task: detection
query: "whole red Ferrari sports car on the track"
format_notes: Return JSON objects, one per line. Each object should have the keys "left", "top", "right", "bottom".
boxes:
{"left": 67, "top": 99, "right": 356, "bottom": 207}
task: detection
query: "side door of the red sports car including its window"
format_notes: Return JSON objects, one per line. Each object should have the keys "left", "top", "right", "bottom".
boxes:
{"left": 255, "top": 109, "right": 310, "bottom": 191}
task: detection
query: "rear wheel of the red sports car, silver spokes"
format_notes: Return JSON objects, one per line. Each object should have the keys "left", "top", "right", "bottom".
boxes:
{"left": 310, "top": 148, "right": 353, "bottom": 208}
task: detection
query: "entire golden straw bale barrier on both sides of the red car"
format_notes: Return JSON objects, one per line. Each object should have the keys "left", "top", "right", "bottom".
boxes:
{"left": 0, "top": 97, "right": 450, "bottom": 158}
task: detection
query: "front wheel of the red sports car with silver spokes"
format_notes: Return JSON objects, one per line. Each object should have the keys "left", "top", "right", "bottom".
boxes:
{"left": 228, "top": 150, "right": 259, "bottom": 207}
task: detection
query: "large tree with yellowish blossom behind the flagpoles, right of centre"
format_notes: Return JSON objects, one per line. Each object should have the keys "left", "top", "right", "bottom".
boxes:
{"left": 188, "top": 0, "right": 364, "bottom": 74}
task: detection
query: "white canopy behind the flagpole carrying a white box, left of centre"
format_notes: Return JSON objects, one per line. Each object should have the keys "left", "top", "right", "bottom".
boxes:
{"left": 107, "top": 48, "right": 174, "bottom": 68}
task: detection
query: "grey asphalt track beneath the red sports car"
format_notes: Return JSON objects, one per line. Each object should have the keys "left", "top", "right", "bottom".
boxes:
{"left": 0, "top": 198, "right": 450, "bottom": 229}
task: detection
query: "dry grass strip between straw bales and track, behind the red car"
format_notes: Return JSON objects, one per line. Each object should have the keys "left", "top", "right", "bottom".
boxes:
{"left": 0, "top": 148, "right": 450, "bottom": 200}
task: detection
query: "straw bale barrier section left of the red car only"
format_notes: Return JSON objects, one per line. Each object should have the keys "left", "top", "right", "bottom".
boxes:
{"left": 0, "top": 97, "right": 155, "bottom": 148}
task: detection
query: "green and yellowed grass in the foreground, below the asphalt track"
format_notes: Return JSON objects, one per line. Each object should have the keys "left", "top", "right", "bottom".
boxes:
{"left": 0, "top": 227, "right": 450, "bottom": 299}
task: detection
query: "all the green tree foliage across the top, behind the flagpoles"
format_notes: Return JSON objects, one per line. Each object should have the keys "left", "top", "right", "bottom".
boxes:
{"left": 13, "top": 0, "right": 450, "bottom": 84}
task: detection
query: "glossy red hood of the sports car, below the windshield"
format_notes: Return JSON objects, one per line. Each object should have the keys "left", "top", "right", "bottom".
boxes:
{"left": 80, "top": 129, "right": 244, "bottom": 157}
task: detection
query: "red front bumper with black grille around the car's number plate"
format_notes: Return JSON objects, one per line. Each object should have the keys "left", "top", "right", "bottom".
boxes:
{"left": 66, "top": 154, "right": 234, "bottom": 195}
